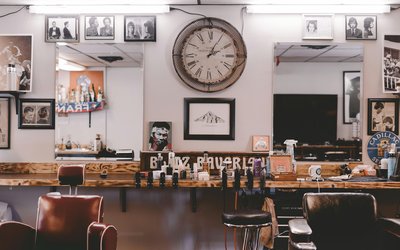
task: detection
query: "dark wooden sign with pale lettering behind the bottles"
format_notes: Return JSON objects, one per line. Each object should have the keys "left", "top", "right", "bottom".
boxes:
{"left": 140, "top": 151, "right": 268, "bottom": 170}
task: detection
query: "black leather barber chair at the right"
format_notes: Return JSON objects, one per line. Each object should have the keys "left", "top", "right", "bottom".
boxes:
{"left": 288, "top": 193, "right": 400, "bottom": 250}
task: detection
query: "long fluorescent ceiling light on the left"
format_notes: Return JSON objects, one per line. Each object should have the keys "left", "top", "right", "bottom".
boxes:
{"left": 29, "top": 5, "right": 169, "bottom": 14}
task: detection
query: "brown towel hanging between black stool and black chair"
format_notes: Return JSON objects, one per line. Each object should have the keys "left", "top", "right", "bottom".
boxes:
{"left": 260, "top": 197, "right": 279, "bottom": 249}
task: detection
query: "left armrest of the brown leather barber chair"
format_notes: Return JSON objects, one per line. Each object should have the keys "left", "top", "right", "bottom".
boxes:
{"left": 0, "top": 221, "right": 35, "bottom": 250}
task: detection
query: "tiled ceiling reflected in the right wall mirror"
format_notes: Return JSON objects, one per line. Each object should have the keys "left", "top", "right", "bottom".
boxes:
{"left": 274, "top": 43, "right": 364, "bottom": 62}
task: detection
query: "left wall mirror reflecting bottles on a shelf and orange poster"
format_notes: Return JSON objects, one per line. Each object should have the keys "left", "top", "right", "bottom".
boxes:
{"left": 55, "top": 43, "right": 143, "bottom": 160}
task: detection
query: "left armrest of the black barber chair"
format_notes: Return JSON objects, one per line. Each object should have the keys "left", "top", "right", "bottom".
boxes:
{"left": 288, "top": 219, "right": 317, "bottom": 250}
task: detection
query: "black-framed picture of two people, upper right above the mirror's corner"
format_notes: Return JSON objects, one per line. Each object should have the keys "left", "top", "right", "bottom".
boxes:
{"left": 344, "top": 15, "right": 378, "bottom": 40}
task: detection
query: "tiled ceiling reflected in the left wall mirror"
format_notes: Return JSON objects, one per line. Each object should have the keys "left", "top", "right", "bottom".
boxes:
{"left": 58, "top": 43, "right": 143, "bottom": 67}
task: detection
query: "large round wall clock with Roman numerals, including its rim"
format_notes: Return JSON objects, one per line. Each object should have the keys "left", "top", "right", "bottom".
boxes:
{"left": 172, "top": 17, "right": 247, "bottom": 92}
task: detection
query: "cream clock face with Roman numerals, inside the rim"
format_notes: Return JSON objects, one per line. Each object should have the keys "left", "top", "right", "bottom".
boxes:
{"left": 182, "top": 28, "right": 237, "bottom": 84}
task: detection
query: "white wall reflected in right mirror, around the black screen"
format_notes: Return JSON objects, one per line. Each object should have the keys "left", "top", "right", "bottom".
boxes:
{"left": 273, "top": 62, "right": 362, "bottom": 140}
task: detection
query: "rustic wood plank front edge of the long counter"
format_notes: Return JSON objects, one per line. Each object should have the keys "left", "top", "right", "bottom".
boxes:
{"left": 0, "top": 162, "right": 400, "bottom": 189}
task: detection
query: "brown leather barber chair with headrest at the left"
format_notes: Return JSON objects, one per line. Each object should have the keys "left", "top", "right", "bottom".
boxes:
{"left": 0, "top": 166, "right": 117, "bottom": 250}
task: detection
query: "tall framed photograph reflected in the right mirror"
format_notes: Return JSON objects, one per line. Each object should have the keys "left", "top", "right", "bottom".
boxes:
{"left": 343, "top": 71, "right": 361, "bottom": 124}
